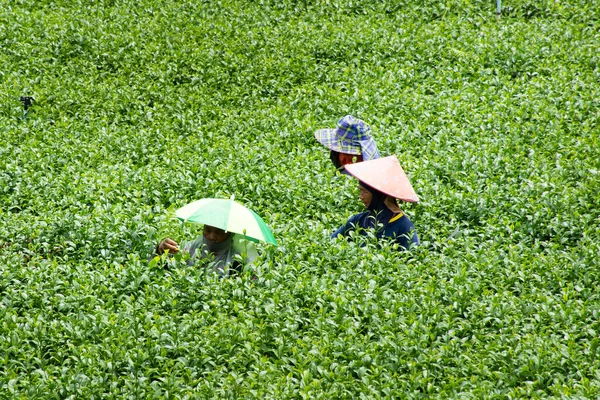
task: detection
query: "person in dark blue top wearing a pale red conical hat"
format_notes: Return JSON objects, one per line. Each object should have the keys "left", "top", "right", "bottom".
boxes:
{"left": 331, "top": 156, "right": 419, "bottom": 249}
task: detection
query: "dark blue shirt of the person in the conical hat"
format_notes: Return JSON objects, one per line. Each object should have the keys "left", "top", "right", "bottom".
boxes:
{"left": 331, "top": 207, "right": 419, "bottom": 249}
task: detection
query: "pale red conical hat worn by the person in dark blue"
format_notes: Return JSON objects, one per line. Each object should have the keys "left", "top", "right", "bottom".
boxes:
{"left": 345, "top": 156, "right": 419, "bottom": 203}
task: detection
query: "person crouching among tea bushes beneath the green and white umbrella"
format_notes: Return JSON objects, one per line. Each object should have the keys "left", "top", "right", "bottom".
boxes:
{"left": 153, "top": 224, "right": 257, "bottom": 276}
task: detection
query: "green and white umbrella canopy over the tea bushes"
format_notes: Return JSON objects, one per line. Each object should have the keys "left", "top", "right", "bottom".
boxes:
{"left": 175, "top": 197, "right": 277, "bottom": 245}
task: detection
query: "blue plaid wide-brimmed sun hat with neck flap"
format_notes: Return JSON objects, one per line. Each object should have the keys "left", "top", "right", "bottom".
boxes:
{"left": 315, "top": 115, "right": 379, "bottom": 161}
